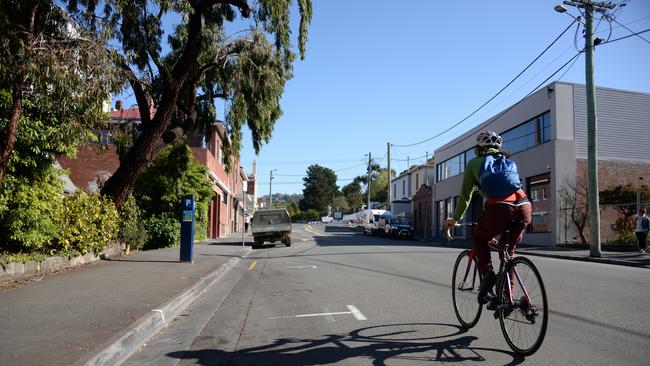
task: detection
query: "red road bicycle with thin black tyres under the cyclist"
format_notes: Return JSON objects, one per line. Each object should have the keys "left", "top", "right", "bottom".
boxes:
{"left": 446, "top": 224, "right": 548, "bottom": 356}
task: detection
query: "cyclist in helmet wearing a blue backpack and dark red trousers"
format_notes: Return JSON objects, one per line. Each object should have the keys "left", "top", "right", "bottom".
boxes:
{"left": 445, "top": 131, "right": 531, "bottom": 304}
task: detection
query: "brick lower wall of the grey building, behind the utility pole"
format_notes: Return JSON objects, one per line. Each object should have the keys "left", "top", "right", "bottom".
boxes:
{"left": 576, "top": 159, "right": 650, "bottom": 242}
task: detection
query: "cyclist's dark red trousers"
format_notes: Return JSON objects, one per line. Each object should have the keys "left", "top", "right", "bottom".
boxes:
{"left": 473, "top": 203, "right": 531, "bottom": 273}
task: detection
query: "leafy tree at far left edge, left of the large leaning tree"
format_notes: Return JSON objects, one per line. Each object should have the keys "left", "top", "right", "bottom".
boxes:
{"left": 0, "top": 0, "right": 117, "bottom": 181}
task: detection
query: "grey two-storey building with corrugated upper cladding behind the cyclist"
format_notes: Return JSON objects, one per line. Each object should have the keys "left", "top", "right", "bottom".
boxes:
{"left": 433, "top": 82, "right": 650, "bottom": 245}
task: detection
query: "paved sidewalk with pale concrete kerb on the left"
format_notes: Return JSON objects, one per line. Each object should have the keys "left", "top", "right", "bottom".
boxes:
{"left": 0, "top": 237, "right": 251, "bottom": 365}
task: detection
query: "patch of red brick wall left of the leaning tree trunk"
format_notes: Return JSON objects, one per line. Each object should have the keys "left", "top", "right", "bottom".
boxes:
{"left": 58, "top": 145, "right": 120, "bottom": 191}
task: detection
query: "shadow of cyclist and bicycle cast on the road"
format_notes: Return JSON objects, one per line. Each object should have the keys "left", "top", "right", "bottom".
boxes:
{"left": 167, "top": 323, "right": 525, "bottom": 366}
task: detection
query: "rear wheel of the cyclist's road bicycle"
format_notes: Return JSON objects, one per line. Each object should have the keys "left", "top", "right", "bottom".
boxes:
{"left": 497, "top": 257, "right": 548, "bottom": 356}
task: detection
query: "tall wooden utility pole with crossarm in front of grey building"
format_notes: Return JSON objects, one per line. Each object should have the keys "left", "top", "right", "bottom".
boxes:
{"left": 556, "top": 0, "right": 616, "bottom": 257}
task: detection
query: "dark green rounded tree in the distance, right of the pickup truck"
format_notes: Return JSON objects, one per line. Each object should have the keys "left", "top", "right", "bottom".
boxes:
{"left": 300, "top": 164, "right": 338, "bottom": 212}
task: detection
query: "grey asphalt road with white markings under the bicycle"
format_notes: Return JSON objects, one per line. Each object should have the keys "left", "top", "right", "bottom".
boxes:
{"left": 129, "top": 224, "right": 650, "bottom": 365}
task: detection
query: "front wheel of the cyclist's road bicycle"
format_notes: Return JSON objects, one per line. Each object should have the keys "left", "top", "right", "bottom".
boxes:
{"left": 451, "top": 250, "right": 483, "bottom": 329}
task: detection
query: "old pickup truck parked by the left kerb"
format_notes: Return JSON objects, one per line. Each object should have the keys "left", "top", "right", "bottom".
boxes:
{"left": 251, "top": 208, "right": 291, "bottom": 247}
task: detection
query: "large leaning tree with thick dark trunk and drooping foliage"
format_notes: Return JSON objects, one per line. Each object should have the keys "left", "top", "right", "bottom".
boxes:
{"left": 67, "top": 0, "right": 312, "bottom": 207}
